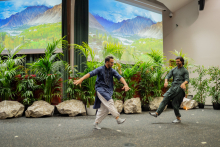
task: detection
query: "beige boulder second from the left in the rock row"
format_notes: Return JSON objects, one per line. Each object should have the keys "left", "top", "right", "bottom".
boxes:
{"left": 25, "top": 100, "right": 54, "bottom": 117}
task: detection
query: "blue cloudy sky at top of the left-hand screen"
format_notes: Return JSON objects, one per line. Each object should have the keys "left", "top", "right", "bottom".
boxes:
{"left": 0, "top": 0, "right": 62, "bottom": 19}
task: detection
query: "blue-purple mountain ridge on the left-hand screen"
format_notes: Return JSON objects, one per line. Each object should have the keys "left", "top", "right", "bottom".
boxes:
{"left": 0, "top": 6, "right": 49, "bottom": 28}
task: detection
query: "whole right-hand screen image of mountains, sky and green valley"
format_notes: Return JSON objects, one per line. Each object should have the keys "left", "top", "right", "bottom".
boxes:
{"left": 89, "top": 0, "right": 163, "bottom": 63}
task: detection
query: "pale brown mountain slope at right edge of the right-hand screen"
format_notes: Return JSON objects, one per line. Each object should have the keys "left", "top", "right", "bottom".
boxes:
{"left": 138, "top": 22, "right": 163, "bottom": 39}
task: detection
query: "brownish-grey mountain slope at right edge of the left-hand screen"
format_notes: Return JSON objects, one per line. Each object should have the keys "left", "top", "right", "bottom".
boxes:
{"left": 27, "top": 4, "right": 62, "bottom": 25}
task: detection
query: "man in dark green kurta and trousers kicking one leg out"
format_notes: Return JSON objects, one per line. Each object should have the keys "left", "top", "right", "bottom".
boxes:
{"left": 150, "top": 57, "right": 189, "bottom": 123}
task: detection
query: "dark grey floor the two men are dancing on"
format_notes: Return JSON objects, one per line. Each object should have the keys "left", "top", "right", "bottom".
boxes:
{"left": 0, "top": 106, "right": 220, "bottom": 147}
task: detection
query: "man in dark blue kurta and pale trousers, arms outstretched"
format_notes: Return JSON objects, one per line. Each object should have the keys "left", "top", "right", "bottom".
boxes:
{"left": 74, "top": 56, "right": 130, "bottom": 129}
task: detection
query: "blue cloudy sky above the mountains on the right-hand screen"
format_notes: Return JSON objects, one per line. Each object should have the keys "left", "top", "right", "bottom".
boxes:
{"left": 89, "top": 0, "right": 162, "bottom": 23}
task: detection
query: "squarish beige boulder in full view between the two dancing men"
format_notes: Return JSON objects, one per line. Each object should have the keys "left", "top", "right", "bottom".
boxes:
{"left": 124, "top": 98, "right": 142, "bottom": 113}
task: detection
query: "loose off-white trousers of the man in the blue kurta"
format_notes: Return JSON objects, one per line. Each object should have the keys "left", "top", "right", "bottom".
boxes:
{"left": 95, "top": 91, "right": 120, "bottom": 124}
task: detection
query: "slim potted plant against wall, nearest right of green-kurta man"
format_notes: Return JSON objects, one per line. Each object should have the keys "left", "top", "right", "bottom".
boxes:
{"left": 190, "top": 65, "right": 209, "bottom": 108}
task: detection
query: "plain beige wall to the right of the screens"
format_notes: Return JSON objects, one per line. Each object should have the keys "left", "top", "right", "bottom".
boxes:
{"left": 163, "top": 0, "right": 220, "bottom": 105}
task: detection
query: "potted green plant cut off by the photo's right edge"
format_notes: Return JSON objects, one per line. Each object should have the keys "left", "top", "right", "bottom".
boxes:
{"left": 208, "top": 66, "right": 220, "bottom": 110}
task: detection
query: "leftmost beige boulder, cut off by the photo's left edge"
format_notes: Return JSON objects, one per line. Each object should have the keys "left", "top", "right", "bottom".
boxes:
{"left": 0, "top": 101, "right": 24, "bottom": 119}
